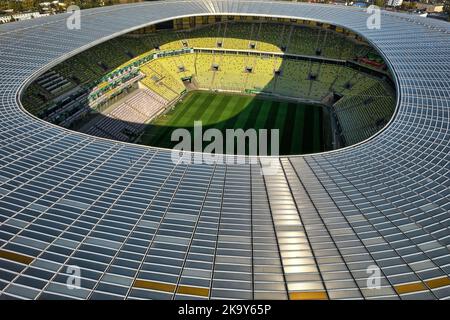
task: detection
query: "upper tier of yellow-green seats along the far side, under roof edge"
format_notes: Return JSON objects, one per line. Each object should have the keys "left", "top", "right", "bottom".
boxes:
{"left": 39, "top": 21, "right": 373, "bottom": 89}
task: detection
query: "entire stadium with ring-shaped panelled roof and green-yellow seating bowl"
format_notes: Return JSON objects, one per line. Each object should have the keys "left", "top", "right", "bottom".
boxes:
{"left": 0, "top": 0, "right": 450, "bottom": 300}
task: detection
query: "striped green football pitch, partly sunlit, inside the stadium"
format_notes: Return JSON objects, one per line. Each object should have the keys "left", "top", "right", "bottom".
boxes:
{"left": 140, "top": 91, "right": 331, "bottom": 155}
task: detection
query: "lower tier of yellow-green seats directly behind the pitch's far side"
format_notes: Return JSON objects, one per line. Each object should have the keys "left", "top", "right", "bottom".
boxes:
{"left": 158, "top": 53, "right": 386, "bottom": 100}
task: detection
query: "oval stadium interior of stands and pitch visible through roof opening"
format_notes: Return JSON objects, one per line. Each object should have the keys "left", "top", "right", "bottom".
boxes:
{"left": 19, "top": 16, "right": 395, "bottom": 155}
